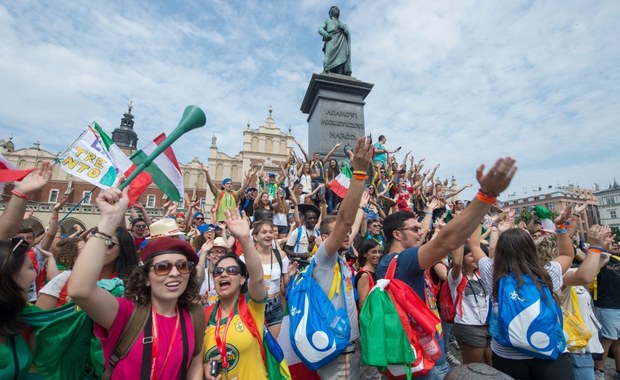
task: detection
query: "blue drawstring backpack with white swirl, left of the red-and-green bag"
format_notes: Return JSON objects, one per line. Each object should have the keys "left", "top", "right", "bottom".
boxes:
{"left": 286, "top": 258, "right": 351, "bottom": 371}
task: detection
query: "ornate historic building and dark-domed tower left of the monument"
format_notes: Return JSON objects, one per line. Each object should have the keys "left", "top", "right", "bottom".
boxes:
{"left": 0, "top": 103, "right": 294, "bottom": 234}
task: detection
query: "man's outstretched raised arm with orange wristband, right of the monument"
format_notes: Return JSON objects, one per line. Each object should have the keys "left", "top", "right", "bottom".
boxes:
{"left": 418, "top": 157, "right": 517, "bottom": 269}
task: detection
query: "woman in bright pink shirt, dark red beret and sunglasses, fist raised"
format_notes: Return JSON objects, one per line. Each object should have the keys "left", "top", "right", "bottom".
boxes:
{"left": 69, "top": 188, "right": 203, "bottom": 379}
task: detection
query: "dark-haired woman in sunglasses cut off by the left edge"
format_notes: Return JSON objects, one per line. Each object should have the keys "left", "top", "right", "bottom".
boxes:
{"left": 0, "top": 238, "right": 37, "bottom": 379}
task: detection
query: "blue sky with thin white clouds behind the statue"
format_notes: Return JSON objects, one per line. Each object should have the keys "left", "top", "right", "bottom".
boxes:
{"left": 0, "top": 0, "right": 620, "bottom": 199}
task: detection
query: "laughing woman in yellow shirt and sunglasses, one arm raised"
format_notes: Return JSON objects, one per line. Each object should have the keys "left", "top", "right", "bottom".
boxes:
{"left": 203, "top": 210, "right": 267, "bottom": 380}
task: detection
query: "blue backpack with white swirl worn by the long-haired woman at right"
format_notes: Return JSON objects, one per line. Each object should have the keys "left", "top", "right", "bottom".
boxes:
{"left": 489, "top": 274, "right": 566, "bottom": 360}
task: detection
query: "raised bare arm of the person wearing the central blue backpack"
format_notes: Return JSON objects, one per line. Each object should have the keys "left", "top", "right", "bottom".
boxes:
{"left": 325, "top": 137, "right": 372, "bottom": 256}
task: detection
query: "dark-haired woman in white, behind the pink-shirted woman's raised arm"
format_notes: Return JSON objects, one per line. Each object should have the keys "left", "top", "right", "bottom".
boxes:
{"left": 36, "top": 227, "right": 138, "bottom": 310}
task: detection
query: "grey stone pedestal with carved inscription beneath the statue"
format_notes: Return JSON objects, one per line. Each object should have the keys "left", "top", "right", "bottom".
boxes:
{"left": 301, "top": 74, "right": 374, "bottom": 159}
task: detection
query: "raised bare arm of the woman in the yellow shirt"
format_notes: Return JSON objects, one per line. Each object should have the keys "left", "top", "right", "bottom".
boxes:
{"left": 225, "top": 210, "right": 267, "bottom": 301}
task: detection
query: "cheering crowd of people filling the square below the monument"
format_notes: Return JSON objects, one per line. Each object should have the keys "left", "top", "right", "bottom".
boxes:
{"left": 0, "top": 135, "right": 620, "bottom": 380}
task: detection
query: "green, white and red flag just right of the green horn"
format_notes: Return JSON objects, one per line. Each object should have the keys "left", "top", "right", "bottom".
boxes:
{"left": 131, "top": 133, "right": 185, "bottom": 201}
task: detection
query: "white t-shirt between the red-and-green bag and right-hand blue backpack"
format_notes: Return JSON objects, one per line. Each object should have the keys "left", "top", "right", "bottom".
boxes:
{"left": 448, "top": 269, "right": 489, "bottom": 326}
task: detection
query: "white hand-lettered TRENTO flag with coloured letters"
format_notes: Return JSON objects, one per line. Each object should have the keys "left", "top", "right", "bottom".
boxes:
{"left": 58, "top": 126, "right": 117, "bottom": 189}
